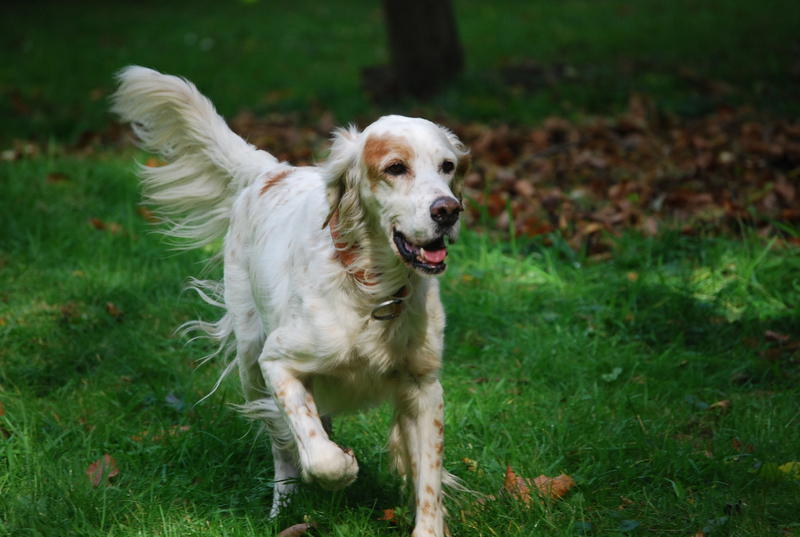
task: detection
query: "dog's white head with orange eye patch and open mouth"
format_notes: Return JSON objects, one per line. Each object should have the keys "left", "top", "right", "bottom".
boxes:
{"left": 324, "top": 116, "right": 469, "bottom": 274}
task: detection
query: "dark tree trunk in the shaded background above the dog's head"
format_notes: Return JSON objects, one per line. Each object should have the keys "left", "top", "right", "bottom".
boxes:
{"left": 383, "top": 0, "right": 464, "bottom": 97}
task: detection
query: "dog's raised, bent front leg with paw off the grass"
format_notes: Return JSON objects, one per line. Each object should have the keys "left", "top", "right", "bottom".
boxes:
{"left": 259, "top": 354, "right": 358, "bottom": 490}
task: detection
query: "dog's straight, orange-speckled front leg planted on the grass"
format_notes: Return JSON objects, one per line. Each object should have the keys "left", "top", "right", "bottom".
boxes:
{"left": 396, "top": 379, "right": 445, "bottom": 537}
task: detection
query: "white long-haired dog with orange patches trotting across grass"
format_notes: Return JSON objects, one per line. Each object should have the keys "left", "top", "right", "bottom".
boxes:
{"left": 112, "top": 66, "right": 469, "bottom": 537}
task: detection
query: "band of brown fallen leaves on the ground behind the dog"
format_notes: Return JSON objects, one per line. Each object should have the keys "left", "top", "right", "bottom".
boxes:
{"left": 15, "top": 94, "right": 800, "bottom": 249}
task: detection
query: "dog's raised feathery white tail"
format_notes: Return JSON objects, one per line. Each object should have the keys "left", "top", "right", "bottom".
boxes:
{"left": 112, "top": 66, "right": 278, "bottom": 248}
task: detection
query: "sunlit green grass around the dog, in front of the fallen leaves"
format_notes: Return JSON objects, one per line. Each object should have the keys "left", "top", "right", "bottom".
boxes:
{"left": 0, "top": 154, "right": 800, "bottom": 537}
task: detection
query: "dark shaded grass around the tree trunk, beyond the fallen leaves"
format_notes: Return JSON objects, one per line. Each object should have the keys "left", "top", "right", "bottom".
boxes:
{"left": 0, "top": 0, "right": 800, "bottom": 145}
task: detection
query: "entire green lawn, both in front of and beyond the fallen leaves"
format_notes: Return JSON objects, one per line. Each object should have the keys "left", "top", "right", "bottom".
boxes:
{"left": 0, "top": 0, "right": 800, "bottom": 537}
